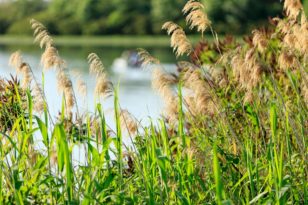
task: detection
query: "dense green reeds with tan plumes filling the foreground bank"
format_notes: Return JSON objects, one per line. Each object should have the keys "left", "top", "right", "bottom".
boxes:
{"left": 0, "top": 0, "right": 308, "bottom": 204}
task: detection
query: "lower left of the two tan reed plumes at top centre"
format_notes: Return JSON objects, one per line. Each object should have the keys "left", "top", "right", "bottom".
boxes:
{"left": 162, "top": 21, "right": 193, "bottom": 57}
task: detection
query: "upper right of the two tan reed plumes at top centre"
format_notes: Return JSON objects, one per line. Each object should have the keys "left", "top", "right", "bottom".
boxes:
{"left": 182, "top": 0, "right": 211, "bottom": 35}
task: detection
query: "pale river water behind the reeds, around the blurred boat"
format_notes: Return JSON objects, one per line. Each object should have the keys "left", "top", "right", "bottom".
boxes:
{"left": 0, "top": 45, "right": 175, "bottom": 127}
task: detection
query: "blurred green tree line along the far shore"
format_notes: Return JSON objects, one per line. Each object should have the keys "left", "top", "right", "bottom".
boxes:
{"left": 0, "top": 0, "right": 308, "bottom": 35}
